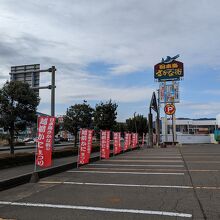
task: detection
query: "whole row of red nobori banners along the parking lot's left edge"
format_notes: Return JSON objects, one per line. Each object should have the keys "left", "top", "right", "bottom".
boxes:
{"left": 36, "top": 116, "right": 145, "bottom": 168}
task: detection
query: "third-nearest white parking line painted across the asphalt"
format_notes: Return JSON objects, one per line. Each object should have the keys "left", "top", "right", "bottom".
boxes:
{"left": 67, "top": 170, "right": 184, "bottom": 176}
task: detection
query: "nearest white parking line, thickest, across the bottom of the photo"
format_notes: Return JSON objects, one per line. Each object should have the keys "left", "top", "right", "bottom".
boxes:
{"left": 0, "top": 201, "right": 192, "bottom": 218}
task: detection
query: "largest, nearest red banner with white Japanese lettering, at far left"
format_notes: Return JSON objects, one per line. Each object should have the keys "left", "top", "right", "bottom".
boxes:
{"left": 36, "top": 116, "right": 55, "bottom": 167}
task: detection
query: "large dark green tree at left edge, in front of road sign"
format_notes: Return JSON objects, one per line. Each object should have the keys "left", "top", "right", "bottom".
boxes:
{"left": 0, "top": 81, "right": 40, "bottom": 155}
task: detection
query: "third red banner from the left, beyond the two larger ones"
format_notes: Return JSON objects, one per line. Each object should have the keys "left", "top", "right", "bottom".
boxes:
{"left": 100, "top": 131, "right": 110, "bottom": 159}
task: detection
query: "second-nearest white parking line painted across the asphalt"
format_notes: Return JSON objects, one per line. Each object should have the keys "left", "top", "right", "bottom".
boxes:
{"left": 40, "top": 181, "right": 193, "bottom": 189}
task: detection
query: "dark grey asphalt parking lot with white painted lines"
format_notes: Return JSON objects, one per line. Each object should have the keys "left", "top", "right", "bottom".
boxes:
{"left": 0, "top": 145, "right": 220, "bottom": 220}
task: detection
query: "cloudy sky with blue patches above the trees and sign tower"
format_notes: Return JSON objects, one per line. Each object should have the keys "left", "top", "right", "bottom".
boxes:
{"left": 0, "top": 0, "right": 220, "bottom": 121}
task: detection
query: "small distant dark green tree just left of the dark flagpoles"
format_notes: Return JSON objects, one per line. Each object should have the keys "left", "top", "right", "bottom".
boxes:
{"left": 126, "top": 115, "right": 148, "bottom": 135}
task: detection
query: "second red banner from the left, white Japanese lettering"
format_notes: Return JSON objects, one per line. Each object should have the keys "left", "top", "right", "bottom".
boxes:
{"left": 78, "top": 129, "right": 93, "bottom": 164}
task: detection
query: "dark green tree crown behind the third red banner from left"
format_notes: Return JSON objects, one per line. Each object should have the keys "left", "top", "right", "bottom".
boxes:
{"left": 94, "top": 100, "right": 118, "bottom": 130}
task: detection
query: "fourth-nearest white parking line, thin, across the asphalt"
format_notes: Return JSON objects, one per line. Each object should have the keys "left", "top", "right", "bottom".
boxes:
{"left": 87, "top": 163, "right": 184, "bottom": 167}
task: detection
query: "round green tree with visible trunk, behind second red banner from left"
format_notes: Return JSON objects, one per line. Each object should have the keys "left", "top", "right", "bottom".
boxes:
{"left": 63, "top": 102, "right": 94, "bottom": 147}
